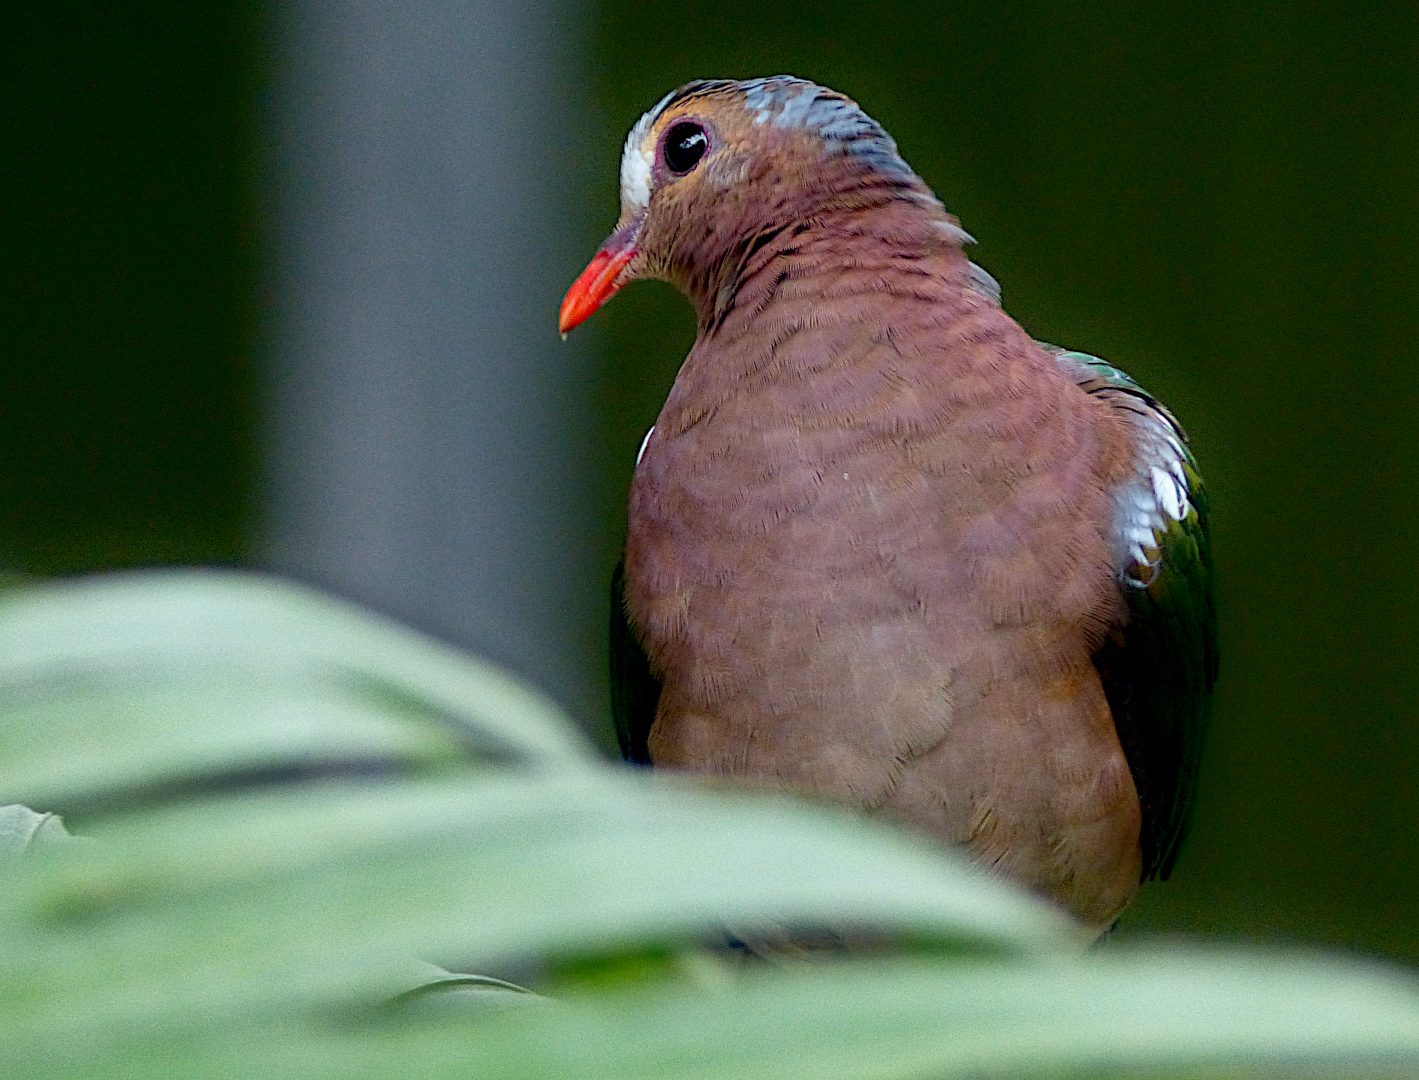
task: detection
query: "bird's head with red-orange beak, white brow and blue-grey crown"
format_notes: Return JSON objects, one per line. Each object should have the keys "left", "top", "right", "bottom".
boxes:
{"left": 559, "top": 75, "right": 945, "bottom": 335}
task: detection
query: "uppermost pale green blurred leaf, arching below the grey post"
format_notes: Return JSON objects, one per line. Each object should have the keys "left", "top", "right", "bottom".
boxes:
{"left": 0, "top": 571, "right": 595, "bottom": 812}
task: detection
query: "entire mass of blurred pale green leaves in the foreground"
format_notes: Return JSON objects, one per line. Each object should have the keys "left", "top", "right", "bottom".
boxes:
{"left": 0, "top": 573, "right": 1419, "bottom": 1080}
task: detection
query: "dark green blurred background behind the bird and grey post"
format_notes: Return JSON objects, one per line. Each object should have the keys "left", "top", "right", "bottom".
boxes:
{"left": 0, "top": 0, "right": 1419, "bottom": 959}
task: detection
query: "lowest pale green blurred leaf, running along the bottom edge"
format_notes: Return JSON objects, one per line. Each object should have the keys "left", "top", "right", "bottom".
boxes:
{"left": 10, "top": 952, "right": 1419, "bottom": 1080}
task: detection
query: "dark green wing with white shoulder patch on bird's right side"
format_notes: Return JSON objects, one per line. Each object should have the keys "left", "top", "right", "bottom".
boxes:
{"left": 1050, "top": 346, "right": 1218, "bottom": 881}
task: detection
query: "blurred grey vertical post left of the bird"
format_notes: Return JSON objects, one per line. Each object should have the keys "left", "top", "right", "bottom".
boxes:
{"left": 261, "top": 0, "right": 604, "bottom": 717}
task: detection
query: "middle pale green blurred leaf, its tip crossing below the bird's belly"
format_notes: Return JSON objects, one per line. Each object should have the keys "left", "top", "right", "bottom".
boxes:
{"left": 0, "top": 766, "right": 1078, "bottom": 1043}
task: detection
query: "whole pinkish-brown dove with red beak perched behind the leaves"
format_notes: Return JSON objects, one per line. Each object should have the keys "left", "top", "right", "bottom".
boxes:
{"left": 559, "top": 75, "right": 1218, "bottom": 932}
